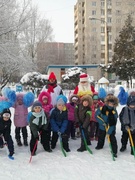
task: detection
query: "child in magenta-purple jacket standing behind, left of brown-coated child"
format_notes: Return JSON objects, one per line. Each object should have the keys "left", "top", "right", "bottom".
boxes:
{"left": 66, "top": 95, "right": 79, "bottom": 140}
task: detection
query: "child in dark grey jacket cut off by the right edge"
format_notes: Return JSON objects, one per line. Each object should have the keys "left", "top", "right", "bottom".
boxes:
{"left": 119, "top": 95, "right": 135, "bottom": 154}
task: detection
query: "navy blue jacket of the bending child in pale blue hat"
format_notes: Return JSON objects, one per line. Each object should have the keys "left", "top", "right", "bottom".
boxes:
{"left": 50, "top": 107, "right": 68, "bottom": 133}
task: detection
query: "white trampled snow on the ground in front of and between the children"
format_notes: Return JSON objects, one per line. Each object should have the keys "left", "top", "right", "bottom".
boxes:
{"left": 0, "top": 96, "right": 135, "bottom": 180}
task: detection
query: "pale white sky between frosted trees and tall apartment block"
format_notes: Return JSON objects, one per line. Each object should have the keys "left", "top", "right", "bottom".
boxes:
{"left": 33, "top": 0, "right": 77, "bottom": 43}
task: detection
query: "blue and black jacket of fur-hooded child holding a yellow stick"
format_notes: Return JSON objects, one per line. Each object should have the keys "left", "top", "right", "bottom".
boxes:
{"left": 95, "top": 105, "right": 118, "bottom": 134}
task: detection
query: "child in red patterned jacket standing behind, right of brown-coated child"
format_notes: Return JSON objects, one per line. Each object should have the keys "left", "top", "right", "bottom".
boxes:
{"left": 90, "top": 92, "right": 104, "bottom": 141}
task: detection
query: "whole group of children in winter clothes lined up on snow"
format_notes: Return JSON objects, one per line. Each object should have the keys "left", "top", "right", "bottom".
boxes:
{"left": 0, "top": 84, "right": 135, "bottom": 157}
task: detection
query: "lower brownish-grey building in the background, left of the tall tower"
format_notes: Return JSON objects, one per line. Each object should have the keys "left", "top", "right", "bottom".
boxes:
{"left": 37, "top": 42, "right": 74, "bottom": 73}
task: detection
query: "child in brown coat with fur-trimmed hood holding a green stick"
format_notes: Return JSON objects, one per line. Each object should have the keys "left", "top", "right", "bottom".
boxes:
{"left": 75, "top": 95, "right": 92, "bottom": 152}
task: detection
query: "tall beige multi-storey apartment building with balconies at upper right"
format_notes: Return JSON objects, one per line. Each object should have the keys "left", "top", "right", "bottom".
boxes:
{"left": 74, "top": 0, "right": 135, "bottom": 64}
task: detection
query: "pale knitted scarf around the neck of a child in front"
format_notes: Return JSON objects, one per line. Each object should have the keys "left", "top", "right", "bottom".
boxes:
{"left": 32, "top": 110, "right": 47, "bottom": 125}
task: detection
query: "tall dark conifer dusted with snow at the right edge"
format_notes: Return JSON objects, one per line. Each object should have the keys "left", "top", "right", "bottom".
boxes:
{"left": 108, "top": 15, "right": 135, "bottom": 86}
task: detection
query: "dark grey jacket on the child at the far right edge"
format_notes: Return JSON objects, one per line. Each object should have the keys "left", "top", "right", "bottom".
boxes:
{"left": 123, "top": 107, "right": 135, "bottom": 129}
